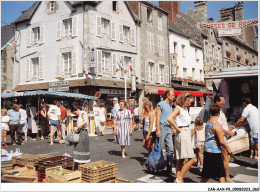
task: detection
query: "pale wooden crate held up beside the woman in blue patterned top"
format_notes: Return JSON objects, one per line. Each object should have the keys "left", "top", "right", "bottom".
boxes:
{"left": 227, "top": 133, "right": 250, "bottom": 154}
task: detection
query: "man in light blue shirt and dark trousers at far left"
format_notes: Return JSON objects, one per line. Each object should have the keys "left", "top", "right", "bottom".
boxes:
{"left": 7, "top": 104, "right": 24, "bottom": 145}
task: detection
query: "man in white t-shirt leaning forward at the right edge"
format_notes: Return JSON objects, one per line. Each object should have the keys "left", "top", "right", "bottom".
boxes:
{"left": 235, "top": 97, "right": 259, "bottom": 159}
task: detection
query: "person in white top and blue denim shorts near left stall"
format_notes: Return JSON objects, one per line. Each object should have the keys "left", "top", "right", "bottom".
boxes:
{"left": 48, "top": 100, "right": 65, "bottom": 145}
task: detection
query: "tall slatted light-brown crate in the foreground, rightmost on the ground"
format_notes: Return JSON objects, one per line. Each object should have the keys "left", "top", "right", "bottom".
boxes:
{"left": 79, "top": 161, "right": 117, "bottom": 183}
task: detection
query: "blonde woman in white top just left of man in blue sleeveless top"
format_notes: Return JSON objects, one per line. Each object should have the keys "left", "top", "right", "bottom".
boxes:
{"left": 143, "top": 101, "right": 156, "bottom": 154}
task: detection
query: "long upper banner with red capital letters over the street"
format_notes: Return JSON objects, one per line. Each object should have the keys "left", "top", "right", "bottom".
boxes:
{"left": 198, "top": 19, "right": 258, "bottom": 29}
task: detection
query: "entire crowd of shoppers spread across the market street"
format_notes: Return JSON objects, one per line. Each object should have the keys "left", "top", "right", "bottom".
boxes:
{"left": 1, "top": 90, "right": 259, "bottom": 183}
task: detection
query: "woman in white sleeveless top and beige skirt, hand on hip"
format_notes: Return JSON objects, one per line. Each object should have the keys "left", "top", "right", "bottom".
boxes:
{"left": 167, "top": 92, "right": 195, "bottom": 183}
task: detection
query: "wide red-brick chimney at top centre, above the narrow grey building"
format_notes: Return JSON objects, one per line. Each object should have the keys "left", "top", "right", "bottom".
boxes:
{"left": 159, "top": 1, "right": 181, "bottom": 23}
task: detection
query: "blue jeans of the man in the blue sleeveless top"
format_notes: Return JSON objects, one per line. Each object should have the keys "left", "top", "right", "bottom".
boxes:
{"left": 160, "top": 124, "right": 173, "bottom": 170}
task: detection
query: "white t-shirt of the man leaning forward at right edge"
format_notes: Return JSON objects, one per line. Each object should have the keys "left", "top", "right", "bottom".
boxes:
{"left": 242, "top": 104, "right": 259, "bottom": 138}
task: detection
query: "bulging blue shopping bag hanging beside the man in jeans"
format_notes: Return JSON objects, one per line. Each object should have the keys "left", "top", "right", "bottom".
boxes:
{"left": 145, "top": 137, "right": 166, "bottom": 172}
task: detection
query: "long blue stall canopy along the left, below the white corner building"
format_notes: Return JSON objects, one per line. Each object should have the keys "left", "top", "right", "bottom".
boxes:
{"left": 1, "top": 91, "right": 98, "bottom": 100}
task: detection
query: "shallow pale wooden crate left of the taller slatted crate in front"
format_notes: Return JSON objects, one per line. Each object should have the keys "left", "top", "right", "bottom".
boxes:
{"left": 45, "top": 166, "right": 81, "bottom": 183}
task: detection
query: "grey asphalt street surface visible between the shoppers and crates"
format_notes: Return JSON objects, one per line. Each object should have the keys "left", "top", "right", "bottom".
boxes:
{"left": 3, "top": 127, "right": 258, "bottom": 183}
